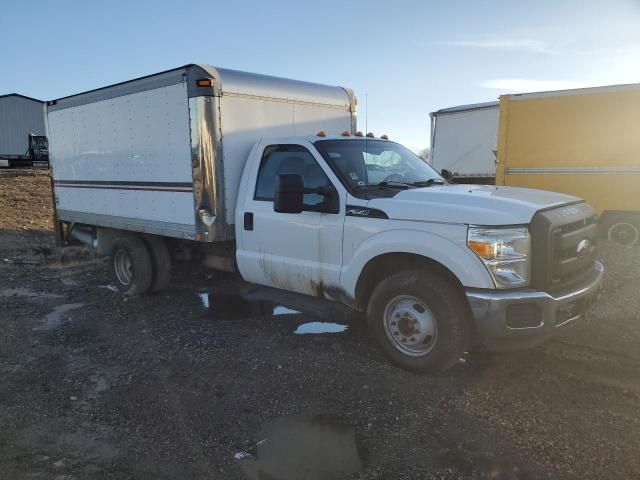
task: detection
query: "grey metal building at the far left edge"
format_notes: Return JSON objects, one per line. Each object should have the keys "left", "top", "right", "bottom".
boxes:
{"left": 0, "top": 93, "right": 45, "bottom": 158}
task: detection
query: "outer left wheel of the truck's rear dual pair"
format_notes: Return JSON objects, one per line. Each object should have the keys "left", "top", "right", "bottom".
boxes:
{"left": 111, "top": 237, "right": 153, "bottom": 295}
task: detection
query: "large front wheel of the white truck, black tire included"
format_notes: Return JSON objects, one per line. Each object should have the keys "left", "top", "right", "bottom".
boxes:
{"left": 367, "top": 270, "right": 472, "bottom": 373}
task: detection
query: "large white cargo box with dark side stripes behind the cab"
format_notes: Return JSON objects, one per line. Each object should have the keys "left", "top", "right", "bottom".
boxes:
{"left": 47, "top": 65, "right": 356, "bottom": 241}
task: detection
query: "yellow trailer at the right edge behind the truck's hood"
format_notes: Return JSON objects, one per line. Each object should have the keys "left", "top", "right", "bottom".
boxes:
{"left": 496, "top": 84, "right": 640, "bottom": 245}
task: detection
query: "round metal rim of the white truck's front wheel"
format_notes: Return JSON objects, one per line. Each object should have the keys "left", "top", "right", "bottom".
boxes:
{"left": 383, "top": 295, "right": 438, "bottom": 357}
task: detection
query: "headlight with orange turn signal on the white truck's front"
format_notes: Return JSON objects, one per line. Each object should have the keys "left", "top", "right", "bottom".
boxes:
{"left": 467, "top": 227, "right": 531, "bottom": 288}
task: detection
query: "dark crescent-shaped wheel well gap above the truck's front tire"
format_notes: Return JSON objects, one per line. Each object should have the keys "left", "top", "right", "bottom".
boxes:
{"left": 355, "top": 253, "right": 462, "bottom": 310}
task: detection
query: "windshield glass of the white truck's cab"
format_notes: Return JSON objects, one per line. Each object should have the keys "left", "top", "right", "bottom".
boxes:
{"left": 314, "top": 138, "right": 445, "bottom": 190}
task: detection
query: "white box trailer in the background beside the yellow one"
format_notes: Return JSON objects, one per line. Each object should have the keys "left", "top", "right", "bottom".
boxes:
{"left": 431, "top": 102, "right": 500, "bottom": 178}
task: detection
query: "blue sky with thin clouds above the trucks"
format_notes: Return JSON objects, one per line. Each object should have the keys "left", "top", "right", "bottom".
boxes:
{"left": 0, "top": 0, "right": 640, "bottom": 149}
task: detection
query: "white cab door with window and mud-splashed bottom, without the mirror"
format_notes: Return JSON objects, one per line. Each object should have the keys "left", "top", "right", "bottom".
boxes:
{"left": 237, "top": 144, "right": 346, "bottom": 297}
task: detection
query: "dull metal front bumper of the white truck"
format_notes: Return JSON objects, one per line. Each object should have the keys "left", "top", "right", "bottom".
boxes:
{"left": 465, "top": 262, "right": 604, "bottom": 350}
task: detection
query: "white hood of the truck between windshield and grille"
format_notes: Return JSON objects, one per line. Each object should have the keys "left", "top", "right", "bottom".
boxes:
{"left": 369, "top": 185, "right": 582, "bottom": 226}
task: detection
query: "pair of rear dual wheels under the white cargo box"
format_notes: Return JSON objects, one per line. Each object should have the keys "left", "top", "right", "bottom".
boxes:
{"left": 111, "top": 236, "right": 171, "bottom": 295}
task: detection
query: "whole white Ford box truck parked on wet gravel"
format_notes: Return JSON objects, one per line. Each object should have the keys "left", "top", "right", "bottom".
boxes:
{"left": 47, "top": 65, "right": 603, "bottom": 371}
